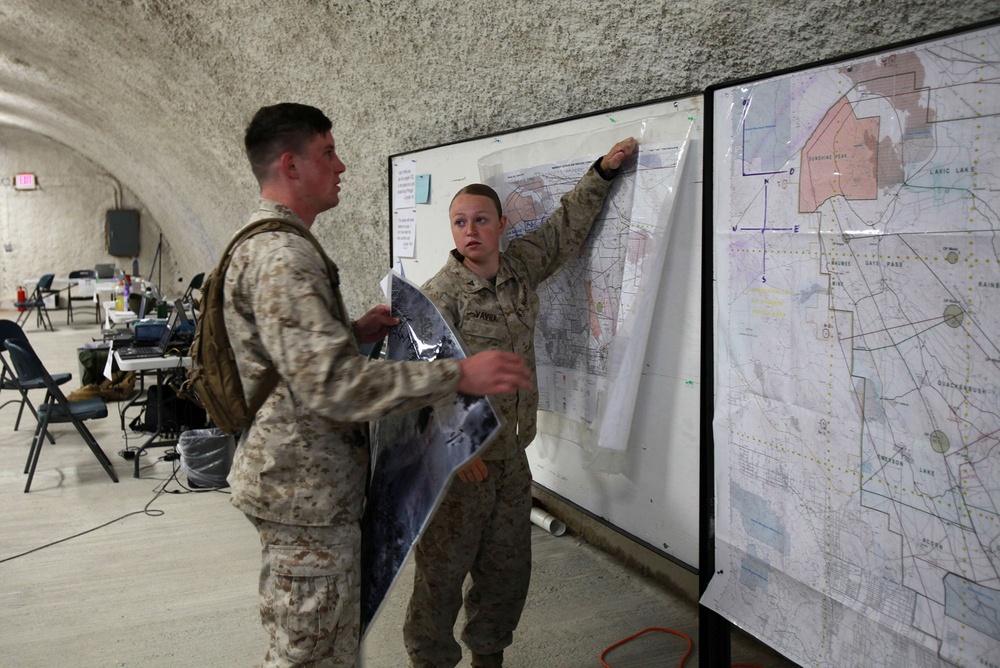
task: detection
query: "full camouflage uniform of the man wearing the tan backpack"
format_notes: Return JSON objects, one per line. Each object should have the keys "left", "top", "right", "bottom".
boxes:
{"left": 224, "top": 200, "right": 460, "bottom": 666}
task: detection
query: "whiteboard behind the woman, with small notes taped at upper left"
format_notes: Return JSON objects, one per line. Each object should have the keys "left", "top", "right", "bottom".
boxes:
{"left": 389, "top": 95, "right": 703, "bottom": 571}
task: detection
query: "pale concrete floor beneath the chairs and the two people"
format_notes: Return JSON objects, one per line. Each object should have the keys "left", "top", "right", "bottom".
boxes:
{"left": 0, "top": 311, "right": 795, "bottom": 668}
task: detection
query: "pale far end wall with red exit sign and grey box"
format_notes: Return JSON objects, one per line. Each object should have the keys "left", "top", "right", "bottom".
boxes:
{"left": 0, "top": 127, "right": 178, "bottom": 298}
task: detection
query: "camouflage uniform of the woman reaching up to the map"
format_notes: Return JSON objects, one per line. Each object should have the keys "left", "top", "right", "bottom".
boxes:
{"left": 403, "top": 161, "right": 613, "bottom": 668}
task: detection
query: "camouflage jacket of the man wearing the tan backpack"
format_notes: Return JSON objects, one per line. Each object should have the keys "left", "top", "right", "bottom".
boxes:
{"left": 224, "top": 200, "right": 460, "bottom": 525}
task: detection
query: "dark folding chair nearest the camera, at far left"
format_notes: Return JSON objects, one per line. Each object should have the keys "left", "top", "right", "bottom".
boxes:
{"left": 7, "top": 339, "right": 118, "bottom": 492}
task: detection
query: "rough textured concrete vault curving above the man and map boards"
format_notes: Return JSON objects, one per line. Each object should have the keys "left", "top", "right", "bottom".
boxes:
{"left": 0, "top": 0, "right": 1000, "bottom": 314}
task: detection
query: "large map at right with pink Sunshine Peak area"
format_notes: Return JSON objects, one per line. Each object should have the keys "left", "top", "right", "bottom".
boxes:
{"left": 703, "top": 27, "right": 1000, "bottom": 666}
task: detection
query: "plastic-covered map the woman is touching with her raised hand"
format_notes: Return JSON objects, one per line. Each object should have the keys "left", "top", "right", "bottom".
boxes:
{"left": 491, "top": 141, "right": 686, "bottom": 448}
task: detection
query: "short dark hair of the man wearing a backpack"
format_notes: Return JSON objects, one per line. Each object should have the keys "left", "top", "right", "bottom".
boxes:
{"left": 243, "top": 102, "right": 333, "bottom": 182}
